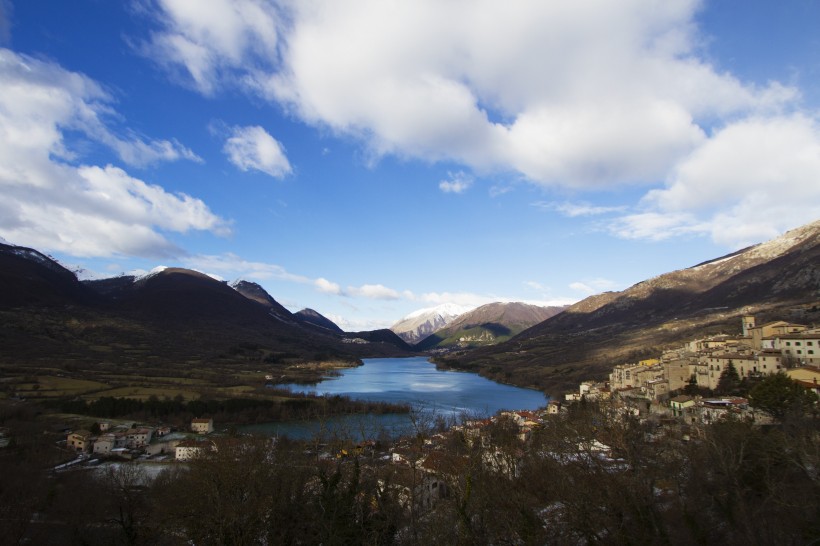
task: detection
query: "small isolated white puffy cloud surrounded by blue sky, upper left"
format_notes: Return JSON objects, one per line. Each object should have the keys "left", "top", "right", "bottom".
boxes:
{"left": 224, "top": 126, "right": 291, "bottom": 178}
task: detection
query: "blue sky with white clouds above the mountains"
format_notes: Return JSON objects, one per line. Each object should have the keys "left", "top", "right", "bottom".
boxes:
{"left": 0, "top": 0, "right": 820, "bottom": 331}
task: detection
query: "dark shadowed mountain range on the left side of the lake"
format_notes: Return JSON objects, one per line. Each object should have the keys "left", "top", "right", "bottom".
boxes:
{"left": 0, "top": 245, "right": 408, "bottom": 376}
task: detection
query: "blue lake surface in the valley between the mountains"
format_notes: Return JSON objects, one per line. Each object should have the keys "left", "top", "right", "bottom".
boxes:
{"left": 242, "top": 357, "right": 549, "bottom": 439}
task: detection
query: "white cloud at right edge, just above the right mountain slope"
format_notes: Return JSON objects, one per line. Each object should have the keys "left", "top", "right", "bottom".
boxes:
{"left": 612, "top": 114, "right": 820, "bottom": 248}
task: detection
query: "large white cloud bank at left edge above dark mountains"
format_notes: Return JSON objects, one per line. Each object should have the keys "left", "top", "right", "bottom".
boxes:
{"left": 0, "top": 50, "right": 230, "bottom": 257}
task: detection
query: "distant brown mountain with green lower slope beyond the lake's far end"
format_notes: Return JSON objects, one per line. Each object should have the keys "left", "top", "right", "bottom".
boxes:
{"left": 416, "top": 302, "right": 566, "bottom": 350}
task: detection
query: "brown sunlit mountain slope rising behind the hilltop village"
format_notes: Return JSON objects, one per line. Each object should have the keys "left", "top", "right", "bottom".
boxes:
{"left": 439, "top": 221, "right": 820, "bottom": 393}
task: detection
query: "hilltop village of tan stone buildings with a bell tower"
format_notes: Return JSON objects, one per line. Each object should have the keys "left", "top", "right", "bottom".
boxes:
{"left": 565, "top": 316, "right": 820, "bottom": 423}
